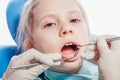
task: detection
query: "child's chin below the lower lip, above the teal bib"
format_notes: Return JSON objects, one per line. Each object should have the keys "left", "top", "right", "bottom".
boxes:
{"left": 50, "top": 59, "right": 82, "bottom": 74}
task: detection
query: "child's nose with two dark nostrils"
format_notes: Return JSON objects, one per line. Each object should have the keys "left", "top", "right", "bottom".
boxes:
{"left": 60, "top": 26, "right": 74, "bottom": 37}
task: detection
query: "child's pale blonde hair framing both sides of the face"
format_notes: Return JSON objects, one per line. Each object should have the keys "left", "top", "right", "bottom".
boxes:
{"left": 16, "top": 0, "right": 88, "bottom": 51}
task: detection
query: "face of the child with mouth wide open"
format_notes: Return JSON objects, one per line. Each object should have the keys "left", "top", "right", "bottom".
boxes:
{"left": 29, "top": 0, "right": 89, "bottom": 73}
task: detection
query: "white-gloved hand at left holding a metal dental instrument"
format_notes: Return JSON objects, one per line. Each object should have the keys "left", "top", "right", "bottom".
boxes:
{"left": 2, "top": 49, "right": 61, "bottom": 80}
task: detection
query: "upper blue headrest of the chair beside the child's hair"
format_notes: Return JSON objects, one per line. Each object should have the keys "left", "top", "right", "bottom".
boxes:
{"left": 6, "top": 0, "right": 27, "bottom": 40}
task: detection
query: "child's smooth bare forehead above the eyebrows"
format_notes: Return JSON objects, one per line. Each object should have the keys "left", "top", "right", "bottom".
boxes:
{"left": 33, "top": 0, "right": 81, "bottom": 16}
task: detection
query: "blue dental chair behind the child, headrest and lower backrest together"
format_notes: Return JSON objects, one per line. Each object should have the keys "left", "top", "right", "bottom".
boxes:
{"left": 0, "top": 0, "right": 26, "bottom": 77}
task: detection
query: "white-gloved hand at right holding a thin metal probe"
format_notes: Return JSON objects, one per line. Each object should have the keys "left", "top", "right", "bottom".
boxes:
{"left": 87, "top": 35, "right": 120, "bottom": 80}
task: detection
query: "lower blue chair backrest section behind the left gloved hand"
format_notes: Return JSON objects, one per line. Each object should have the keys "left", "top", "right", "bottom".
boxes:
{"left": 0, "top": 45, "right": 18, "bottom": 77}
